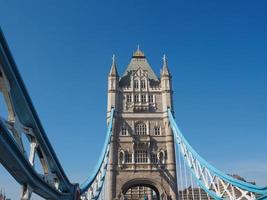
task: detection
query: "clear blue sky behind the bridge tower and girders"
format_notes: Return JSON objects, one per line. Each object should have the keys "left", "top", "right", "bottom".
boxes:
{"left": 0, "top": 0, "right": 267, "bottom": 199}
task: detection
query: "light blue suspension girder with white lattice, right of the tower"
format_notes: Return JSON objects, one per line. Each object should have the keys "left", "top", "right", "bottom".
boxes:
{"left": 167, "top": 109, "right": 267, "bottom": 200}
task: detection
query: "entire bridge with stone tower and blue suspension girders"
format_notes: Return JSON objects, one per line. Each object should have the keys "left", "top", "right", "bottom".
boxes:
{"left": 0, "top": 28, "right": 267, "bottom": 200}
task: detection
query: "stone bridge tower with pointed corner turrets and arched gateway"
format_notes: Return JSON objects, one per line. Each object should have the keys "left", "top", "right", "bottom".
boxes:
{"left": 105, "top": 48, "right": 177, "bottom": 200}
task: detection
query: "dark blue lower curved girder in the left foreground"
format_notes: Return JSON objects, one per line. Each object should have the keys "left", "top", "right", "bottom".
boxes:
{"left": 0, "top": 120, "right": 77, "bottom": 200}
